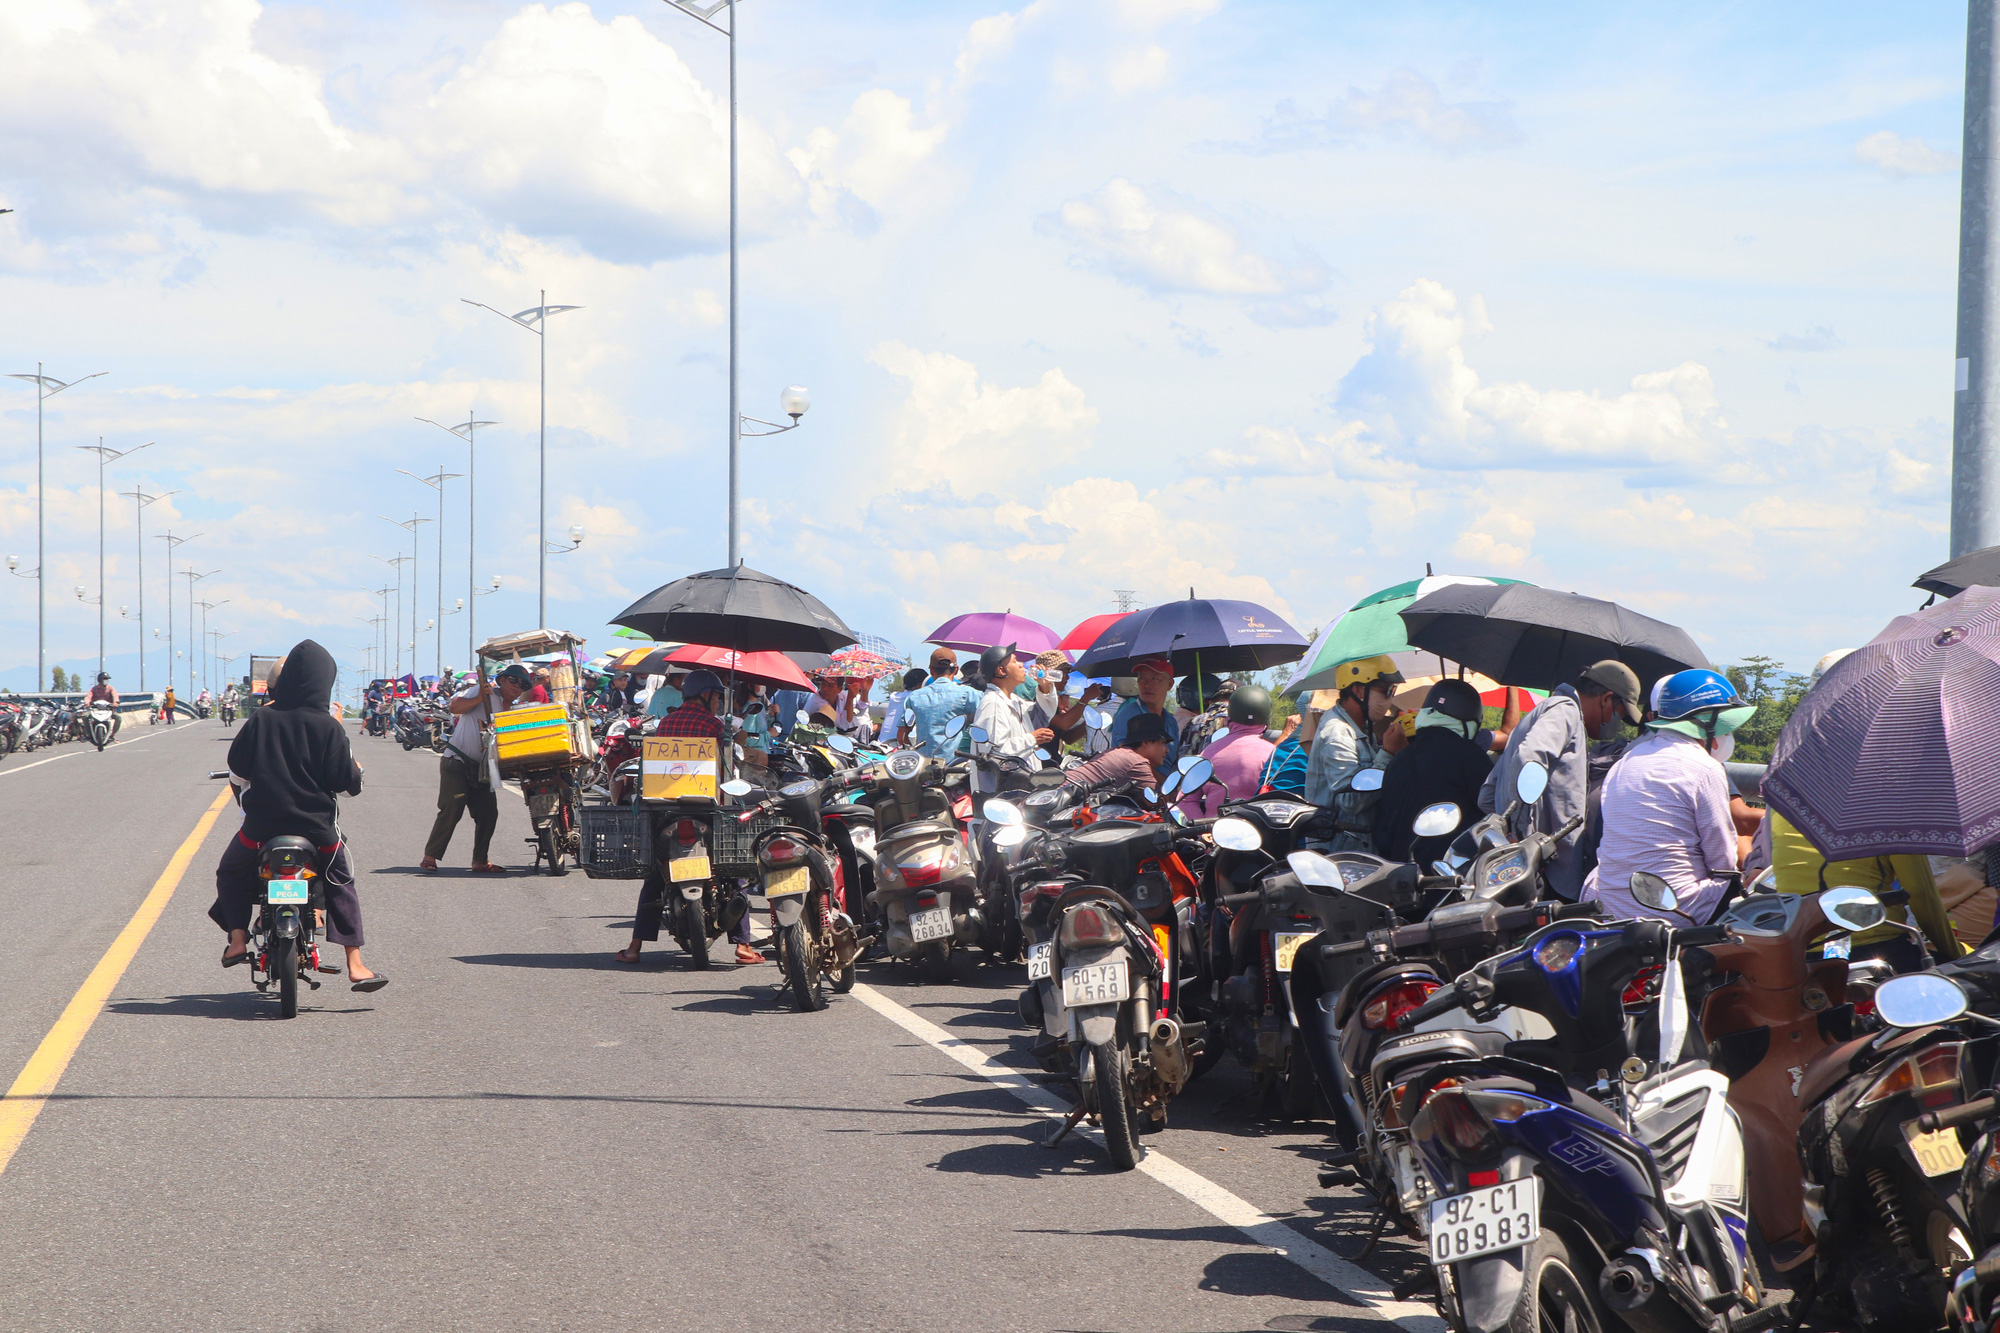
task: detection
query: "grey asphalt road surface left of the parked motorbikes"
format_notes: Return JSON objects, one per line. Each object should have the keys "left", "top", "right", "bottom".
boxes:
{"left": 0, "top": 723, "right": 1422, "bottom": 1333}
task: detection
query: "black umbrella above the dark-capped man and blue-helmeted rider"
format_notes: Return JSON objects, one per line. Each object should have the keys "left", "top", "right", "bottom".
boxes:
{"left": 1402, "top": 582, "right": 1708, "bottom": 691}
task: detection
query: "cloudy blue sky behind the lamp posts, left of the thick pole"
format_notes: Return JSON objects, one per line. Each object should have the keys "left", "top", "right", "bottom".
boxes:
{"left": 0, "top": 0, "right": 1964, "bottom": 681}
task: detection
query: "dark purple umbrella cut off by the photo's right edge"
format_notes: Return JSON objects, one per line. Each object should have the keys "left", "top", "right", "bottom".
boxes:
{"left": 1764, "top": 588, "right": 2000, "bottom": 861}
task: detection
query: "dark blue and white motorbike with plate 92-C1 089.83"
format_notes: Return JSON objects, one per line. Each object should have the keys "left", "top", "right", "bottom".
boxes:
{"left": 1398, "top": 881, "right": 1788, "bottom": 1333}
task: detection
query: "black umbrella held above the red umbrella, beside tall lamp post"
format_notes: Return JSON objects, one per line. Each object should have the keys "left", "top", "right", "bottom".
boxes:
{"left": 612, "top": 564, "right": 858, "bottom": 652}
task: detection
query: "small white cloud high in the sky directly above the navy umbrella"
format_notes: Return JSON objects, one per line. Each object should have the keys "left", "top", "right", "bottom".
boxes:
{"left": 1046, "top": 176, "right": 1326, "bottom": 296}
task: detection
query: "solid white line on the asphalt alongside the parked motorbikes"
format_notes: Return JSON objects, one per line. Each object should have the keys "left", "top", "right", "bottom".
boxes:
{"left": 854, "top": 983, "right": 1444, "bottom": 1333}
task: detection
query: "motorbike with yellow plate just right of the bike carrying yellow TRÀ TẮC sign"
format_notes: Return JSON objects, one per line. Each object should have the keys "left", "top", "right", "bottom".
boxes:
{"left": 722, "top": 768, "right": 868, "bottom": 1011}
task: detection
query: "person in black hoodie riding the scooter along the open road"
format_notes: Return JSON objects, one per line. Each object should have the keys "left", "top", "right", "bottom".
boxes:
{"left": 208, "top": 638, "right": 388, "bottom": 991}
